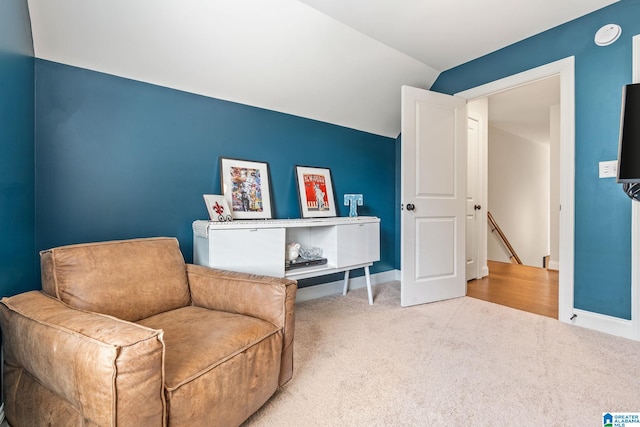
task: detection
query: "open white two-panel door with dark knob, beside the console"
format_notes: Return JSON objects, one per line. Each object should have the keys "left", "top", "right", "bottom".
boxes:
{"left": 400, "top": 86, "right": 467, "bottom": 306}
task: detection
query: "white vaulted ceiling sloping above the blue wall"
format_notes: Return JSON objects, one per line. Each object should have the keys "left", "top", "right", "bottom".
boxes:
{"left": 28, "top": 0, "right": 616, "bottom": 137}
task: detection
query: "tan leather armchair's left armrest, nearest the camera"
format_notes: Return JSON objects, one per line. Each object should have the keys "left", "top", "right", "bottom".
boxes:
{"left": 0, "top": 291, "right": 165, "bottom": 425}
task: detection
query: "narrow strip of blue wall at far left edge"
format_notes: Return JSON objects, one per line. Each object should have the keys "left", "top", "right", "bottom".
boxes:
{"left": 0, "top": 0, "right": 35, "bottom": 296}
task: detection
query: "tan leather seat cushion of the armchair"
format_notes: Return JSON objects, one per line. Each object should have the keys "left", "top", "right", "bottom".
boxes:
{"left": 139, "top": 306, "right": 282, "bottom": 426}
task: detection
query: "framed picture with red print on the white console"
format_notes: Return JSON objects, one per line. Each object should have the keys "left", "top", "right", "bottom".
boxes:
{"left": 296, "top": 166, "right": 336, "bottom": 218}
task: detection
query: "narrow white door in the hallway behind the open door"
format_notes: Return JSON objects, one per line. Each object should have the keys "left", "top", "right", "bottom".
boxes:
{"left": 465, "top": 115, "right": 483, "bottom": 281}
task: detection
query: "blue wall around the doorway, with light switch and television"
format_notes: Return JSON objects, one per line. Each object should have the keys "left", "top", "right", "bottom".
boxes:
{"left": 431, "top": 0, "right": 640, "bottom": 319}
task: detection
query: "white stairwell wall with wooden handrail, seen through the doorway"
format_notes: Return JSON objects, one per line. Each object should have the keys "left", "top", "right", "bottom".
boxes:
{"left": 487, "top": 125, "right": 550, "bottom": 267}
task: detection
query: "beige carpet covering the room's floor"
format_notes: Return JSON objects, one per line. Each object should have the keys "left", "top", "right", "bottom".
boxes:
{"left": 245, "top": 282, "right": 640, "bottom": 427}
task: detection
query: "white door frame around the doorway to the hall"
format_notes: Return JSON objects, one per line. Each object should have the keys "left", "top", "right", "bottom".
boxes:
{"left": 455, "top": 56, "right": 575, "bottom": 323}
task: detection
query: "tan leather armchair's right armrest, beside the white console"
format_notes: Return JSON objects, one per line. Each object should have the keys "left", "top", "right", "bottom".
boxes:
{"left": 187, "top": 264, "right": 298, "bottom": 385}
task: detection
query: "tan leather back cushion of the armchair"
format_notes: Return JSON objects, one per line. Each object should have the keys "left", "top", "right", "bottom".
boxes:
{"left": 40, "top": 237, "right": 191, "bottom": 322}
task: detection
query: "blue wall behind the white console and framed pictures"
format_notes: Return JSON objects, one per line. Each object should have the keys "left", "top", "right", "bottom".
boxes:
{"left": 35, "top": 59, "right": 396, "bottom": 286}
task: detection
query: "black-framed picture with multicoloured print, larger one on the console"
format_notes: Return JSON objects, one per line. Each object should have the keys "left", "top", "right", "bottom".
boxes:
{"left": 220, "top": 157, "right": 271, "bottom": 219}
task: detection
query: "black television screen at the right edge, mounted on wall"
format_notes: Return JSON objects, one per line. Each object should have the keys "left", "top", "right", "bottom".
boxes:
{"left": 618, "top": 84, "right": 640, "bottom": 184}
